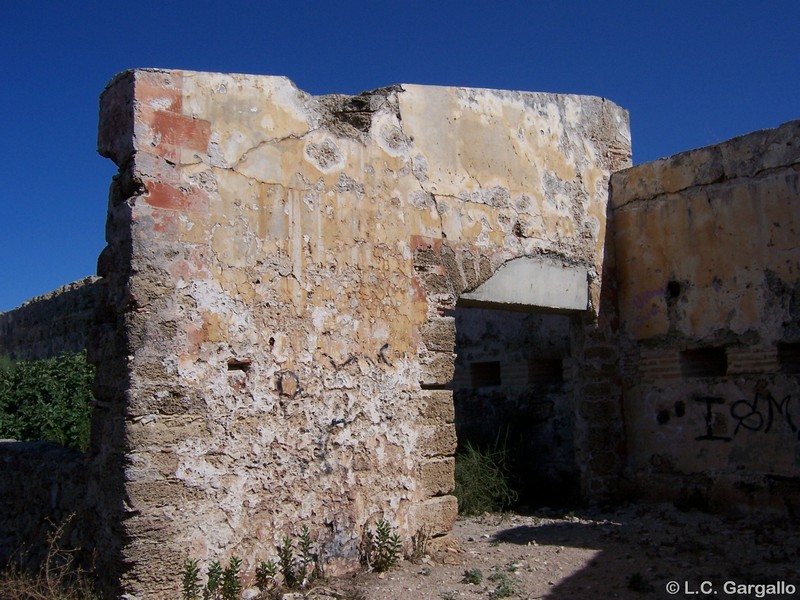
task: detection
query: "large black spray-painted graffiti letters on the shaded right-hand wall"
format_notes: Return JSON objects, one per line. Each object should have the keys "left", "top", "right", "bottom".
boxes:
{"left": 695, "top": 382, "right": 800, "bottom": 442}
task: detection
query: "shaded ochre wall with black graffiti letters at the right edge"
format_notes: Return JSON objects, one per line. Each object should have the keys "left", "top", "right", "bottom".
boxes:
{"left": 612, "top": 121, "right": 800, "bottom": 514}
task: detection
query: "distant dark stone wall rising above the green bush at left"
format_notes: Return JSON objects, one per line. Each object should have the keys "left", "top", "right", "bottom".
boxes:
{"left": 0, "top": 277, "right": 100, "bottom": 360}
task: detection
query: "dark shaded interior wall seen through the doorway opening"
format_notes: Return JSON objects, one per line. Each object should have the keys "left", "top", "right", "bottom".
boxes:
{"left": 452, "top": 308, "right": 580, "bottom": 507}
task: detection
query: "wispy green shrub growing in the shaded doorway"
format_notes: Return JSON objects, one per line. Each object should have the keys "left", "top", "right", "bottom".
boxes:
{"left": 454, "top": 442, "right": 517, "bottom": 515}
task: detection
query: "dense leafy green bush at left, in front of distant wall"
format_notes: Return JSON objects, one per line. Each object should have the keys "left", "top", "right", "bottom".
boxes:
{"left": 0, "top": 352, "right": 94, "bottom": 451}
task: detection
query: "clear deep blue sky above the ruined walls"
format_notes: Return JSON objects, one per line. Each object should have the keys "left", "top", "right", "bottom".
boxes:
{"left": 0, "top": 0, "right": 800, "bottom": 311}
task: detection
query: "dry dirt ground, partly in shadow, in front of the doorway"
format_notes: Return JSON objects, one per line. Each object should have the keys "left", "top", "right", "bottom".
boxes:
{"left": 302, "top": 504, "right": 800, "bottom": 600}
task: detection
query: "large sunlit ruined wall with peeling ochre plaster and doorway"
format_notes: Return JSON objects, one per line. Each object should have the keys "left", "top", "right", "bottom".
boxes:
{"left": 87, "top": 70, "right": 630, "bottom": 598}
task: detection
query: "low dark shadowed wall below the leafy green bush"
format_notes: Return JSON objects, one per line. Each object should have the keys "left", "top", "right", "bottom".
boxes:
{"left": 0, "top": 440, "right": 86, "bottom": 568}
